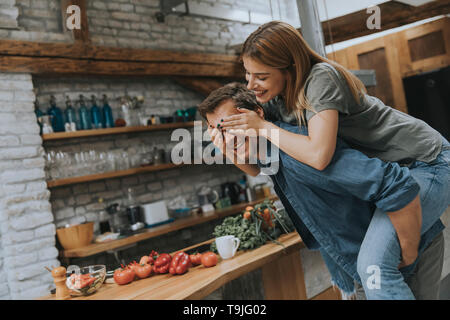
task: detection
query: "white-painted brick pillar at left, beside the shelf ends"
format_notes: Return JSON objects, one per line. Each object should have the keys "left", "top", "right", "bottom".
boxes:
{"left": 0, "top": 73, "right": 59, "bottom": 299}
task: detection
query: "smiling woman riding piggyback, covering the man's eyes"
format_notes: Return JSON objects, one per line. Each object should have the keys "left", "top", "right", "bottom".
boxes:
{"left": 221, "top": 21, "right": 450, "bottom": 299}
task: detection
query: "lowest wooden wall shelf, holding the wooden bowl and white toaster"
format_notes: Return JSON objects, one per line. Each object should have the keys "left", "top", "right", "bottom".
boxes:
{"left": 61, "top": 196, "right": 278, "bottom": 258}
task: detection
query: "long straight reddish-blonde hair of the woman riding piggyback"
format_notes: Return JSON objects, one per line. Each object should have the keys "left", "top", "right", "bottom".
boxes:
{"left": 240, "top": 21, "right": 367, "bottom": 124}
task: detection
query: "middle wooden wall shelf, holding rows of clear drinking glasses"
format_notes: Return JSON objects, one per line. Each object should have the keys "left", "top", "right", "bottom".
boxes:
{"left": 47, "top": 163, "right": 185, "bottom": 188}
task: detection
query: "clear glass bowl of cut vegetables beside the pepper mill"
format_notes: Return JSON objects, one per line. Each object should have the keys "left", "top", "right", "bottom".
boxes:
{"left": 66, "top": 265, "right": 106, "bottom": 296}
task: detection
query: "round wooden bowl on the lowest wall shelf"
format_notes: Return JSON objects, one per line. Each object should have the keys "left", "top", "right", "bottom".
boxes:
{"left": 56, "top": 222, "right": 94, "bottom": 250}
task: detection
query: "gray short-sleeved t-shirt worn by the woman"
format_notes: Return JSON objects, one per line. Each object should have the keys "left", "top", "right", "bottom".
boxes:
{"left": 263, "top": 62, "right": 442, "bottom": 164}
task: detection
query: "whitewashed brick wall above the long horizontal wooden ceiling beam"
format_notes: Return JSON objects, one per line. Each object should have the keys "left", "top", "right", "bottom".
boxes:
{"left": 0, "top": 0, "right": 284, "bottom": 53}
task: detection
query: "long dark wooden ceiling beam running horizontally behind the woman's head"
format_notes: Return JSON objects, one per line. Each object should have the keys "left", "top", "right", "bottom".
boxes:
{"left": 0, "top": 40, "right": 244, "bottom": 78}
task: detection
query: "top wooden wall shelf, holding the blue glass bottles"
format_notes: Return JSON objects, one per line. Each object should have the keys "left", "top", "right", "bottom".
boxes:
{"left": 42, "top": 121, "right": 194, "bottom": 142}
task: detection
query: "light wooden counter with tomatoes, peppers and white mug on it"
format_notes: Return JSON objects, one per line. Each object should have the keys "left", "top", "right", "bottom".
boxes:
{"left": 40, "top": 232, "right": 312, "bottom": 300}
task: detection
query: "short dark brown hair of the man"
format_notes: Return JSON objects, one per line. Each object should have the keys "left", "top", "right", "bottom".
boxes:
{"left": 198, "top": 82, "right": 261, "bottom": 119}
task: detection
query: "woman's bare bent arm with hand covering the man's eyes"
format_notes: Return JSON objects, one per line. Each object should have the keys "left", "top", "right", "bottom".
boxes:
{"left": 222, "top": 108, "right": 338, "bottom": 170}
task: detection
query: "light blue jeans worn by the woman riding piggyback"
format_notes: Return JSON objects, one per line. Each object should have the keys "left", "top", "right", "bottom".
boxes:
{"left": 357, "top": 138, "right": 450, "bottom": 300}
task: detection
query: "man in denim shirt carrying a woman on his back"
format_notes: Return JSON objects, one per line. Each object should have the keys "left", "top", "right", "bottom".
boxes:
{"left": 199, "top": 83, "right": 444, "bottom": 299}
